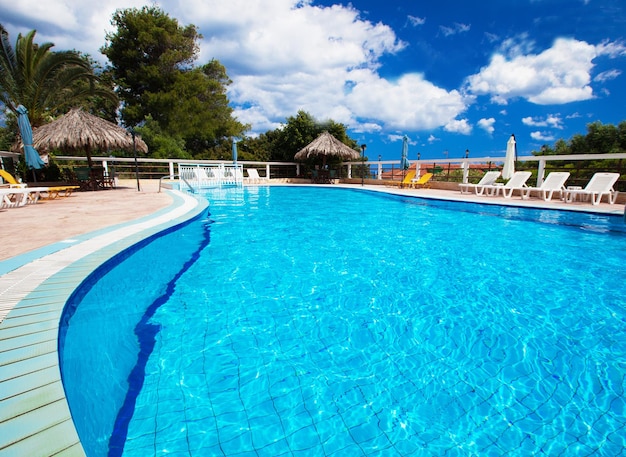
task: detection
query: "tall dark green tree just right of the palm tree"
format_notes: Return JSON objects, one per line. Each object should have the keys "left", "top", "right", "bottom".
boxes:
{"left": 102, "top": 6, "right": 248, "bottom": 158}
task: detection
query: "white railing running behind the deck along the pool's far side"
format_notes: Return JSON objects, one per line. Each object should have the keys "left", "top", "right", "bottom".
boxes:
{"left": 54, "top": 153, "right": 626, "bottom": 191}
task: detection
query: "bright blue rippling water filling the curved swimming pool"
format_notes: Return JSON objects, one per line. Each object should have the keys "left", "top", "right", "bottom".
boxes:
{"left": 60, "top": 187, "right": 626, "bottom": 457}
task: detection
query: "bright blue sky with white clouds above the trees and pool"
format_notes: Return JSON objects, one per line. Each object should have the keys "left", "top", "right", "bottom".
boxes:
{"left": 0, "top": 0, "right": 626, "bottom": 160}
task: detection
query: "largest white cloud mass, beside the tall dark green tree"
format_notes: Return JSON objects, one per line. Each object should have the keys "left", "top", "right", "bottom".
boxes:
{"left": 176, "top": 0, "right": 469, "bottom": 132}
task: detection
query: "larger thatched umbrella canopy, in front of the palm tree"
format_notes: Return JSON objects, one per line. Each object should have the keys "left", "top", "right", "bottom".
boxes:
{"left": 28, "top": 108, "right": 148, "bottom": 166}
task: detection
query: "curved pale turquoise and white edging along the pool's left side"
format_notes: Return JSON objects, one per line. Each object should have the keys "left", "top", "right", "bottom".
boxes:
{"left": 0, "top": 191, "right": 208, "bottom": 456}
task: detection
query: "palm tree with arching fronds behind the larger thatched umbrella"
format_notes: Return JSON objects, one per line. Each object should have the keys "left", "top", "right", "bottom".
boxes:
{"left": 0, "top": 24, "right": 117, "bottom": 127}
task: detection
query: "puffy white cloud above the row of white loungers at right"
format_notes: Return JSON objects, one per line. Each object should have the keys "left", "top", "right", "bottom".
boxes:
{"left": 467, "top": 38, "right": 625, "bottom": 105}
